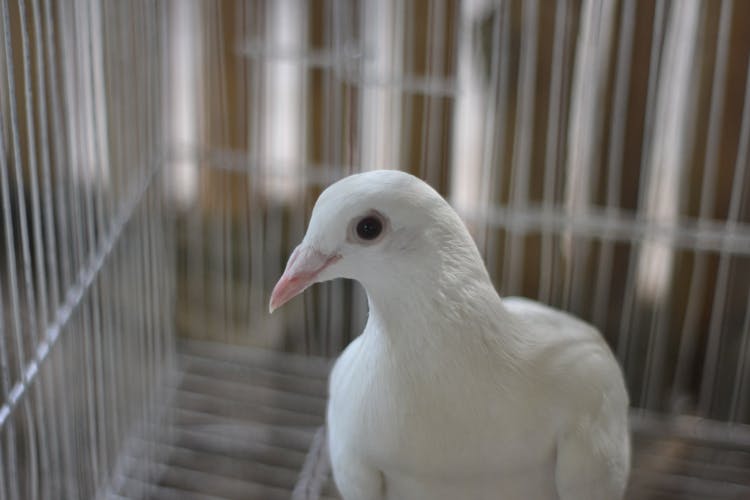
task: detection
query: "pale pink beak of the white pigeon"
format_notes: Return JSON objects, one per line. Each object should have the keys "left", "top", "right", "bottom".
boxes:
{"left": 268, "top": 244, "right": 341, "bottom": 312}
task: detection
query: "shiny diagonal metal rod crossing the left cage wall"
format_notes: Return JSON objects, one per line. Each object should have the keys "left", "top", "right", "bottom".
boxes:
{"left": 0, "top": 162, "right": 163, "bottom": 429}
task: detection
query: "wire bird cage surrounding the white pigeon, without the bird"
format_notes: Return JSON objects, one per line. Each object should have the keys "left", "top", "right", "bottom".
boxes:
{"left": 0, "top": 0, "right": 750, "bottom": 500}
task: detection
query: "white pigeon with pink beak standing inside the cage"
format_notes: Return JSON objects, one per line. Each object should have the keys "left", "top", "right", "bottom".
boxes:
{"left": 270, "top": 170, "right": 630, "bottom": 500}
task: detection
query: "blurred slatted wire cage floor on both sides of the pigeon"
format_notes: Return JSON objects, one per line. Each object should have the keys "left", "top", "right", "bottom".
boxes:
{"left": 114, "top": 342, "right": 750, "bottom": 500}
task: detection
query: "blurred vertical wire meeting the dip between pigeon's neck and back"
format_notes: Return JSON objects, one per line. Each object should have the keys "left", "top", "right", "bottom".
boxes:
{"left": 502, "top": 0, "right": 539, "bottom": 293}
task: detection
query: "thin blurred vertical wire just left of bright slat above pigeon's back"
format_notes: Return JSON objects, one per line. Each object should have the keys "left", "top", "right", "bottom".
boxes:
{"left": 539, "top": 0, "right": 569, "bottom": 303}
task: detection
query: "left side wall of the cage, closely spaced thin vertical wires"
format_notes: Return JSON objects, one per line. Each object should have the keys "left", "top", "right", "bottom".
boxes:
{"left": 0, "top": 0, "right": 174, "bottom": 500}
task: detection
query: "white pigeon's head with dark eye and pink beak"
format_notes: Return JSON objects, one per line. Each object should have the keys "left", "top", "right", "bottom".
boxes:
{"left": 269, "top": 170, "right": 481, "bottom": 312}
